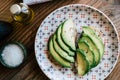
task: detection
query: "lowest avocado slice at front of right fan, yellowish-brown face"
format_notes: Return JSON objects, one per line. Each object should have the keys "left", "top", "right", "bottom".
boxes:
{"left": 76, "top": 49, "right": 90, "bottom": 76}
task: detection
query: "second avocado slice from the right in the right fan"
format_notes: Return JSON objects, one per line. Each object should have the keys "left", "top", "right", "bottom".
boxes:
{"left": 82, "top": 37, "right": 100, "bottom": 66}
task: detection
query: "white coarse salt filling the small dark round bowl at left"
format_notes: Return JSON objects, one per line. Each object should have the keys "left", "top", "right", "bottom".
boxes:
{"left": 2, "top": 44, "right": 24, "bottom": 67}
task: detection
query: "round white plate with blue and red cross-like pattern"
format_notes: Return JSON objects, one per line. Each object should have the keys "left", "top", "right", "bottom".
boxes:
{"left": 35, "top": 4, "right": 119, "bottom": 80}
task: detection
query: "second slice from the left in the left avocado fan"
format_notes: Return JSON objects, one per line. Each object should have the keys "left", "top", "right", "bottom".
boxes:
{"left": 53, "top": 34, "right": 74, "bottom": 62}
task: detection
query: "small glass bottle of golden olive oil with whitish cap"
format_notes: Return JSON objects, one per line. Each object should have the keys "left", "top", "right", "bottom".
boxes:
{"left": 10, "top": 3, "right": 34, "bottom": 24}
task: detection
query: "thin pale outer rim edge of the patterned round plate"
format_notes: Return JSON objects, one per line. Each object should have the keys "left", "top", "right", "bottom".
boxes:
{"left": 34, "top": 4, "right": 120, "bottom": 79}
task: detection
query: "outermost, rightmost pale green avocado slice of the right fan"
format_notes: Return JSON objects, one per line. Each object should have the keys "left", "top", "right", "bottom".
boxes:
{"left": 83, "top": 26, "right": 104, "bottom": 59}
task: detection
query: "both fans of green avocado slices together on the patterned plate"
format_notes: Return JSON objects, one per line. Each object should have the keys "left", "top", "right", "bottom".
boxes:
{"left": 48, "top": 19, "right": 105, "bottom": 76}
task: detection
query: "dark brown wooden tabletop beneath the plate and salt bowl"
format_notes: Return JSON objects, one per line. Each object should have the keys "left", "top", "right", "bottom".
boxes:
{"left": 0, "top": 0, "right": 120, "bottom": 80}
